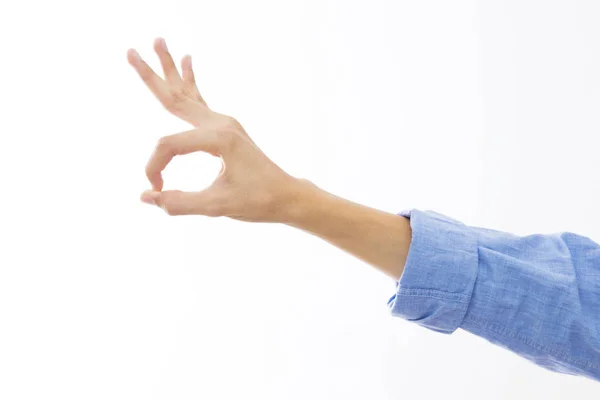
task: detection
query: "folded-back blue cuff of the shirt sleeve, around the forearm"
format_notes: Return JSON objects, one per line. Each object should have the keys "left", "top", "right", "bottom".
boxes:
{"left": 387, "top": 209, "right": 478, "bottom": 334}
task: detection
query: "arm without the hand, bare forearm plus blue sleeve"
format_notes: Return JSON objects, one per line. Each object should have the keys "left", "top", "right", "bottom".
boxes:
{"left": 286, "top": 182, "right": 600, "bottom": 380}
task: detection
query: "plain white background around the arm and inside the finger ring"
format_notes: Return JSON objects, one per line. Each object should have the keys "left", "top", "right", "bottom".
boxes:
{"left": 0, "top": 0, "right": 600, "bottom": 400}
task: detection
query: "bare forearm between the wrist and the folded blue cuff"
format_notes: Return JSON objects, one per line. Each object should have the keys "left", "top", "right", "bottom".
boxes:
{"left": 281, "top": 180, "right": 411, "bottom": 280}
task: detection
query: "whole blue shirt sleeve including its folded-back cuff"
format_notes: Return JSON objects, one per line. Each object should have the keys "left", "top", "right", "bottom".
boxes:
{"left": 388, "top": 209, "right": 600, "bottom": 380}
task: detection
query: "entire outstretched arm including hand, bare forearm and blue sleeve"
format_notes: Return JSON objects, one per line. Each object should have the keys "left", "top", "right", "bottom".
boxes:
{"left": 128, "top": 40, "right": 600, "bottom": 380}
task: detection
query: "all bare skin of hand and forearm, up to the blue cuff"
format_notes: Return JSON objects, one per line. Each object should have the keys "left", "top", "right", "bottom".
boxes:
{"left": 127, "top": 38, "right": 412, "bottom": 280}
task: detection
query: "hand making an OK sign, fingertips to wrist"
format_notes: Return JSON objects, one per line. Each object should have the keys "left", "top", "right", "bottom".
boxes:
{"left": 128, "top": 39, "right": 308, "bottom": 222}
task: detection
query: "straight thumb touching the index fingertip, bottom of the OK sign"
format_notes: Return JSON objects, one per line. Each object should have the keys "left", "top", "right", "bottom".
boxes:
{"left": 140, "top": 189, "right": 223, "bottom": 217}
